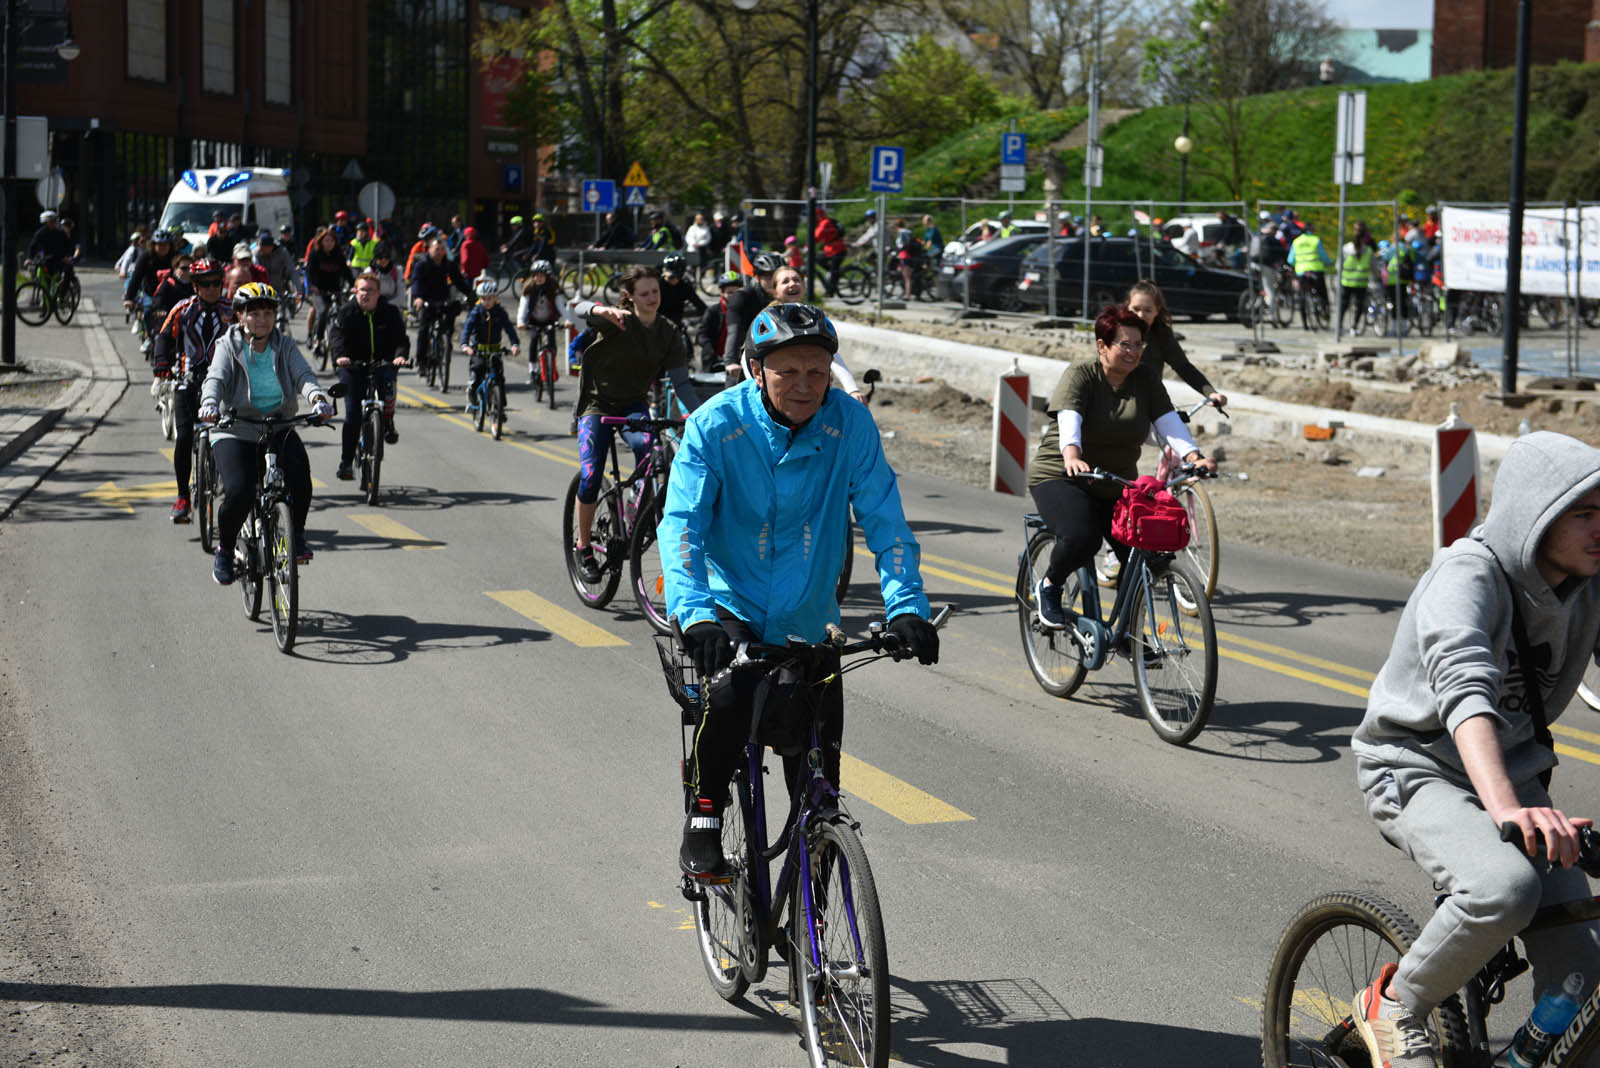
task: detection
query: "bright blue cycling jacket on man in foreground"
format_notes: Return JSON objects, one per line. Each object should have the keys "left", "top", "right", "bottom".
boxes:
{"left": 656, "top": 381, "right": 928, "bottom": 644}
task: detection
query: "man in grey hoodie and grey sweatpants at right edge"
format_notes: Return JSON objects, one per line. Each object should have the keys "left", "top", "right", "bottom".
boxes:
{"left": 1350, "top": 433, "right": 1600, "bottom": 1068}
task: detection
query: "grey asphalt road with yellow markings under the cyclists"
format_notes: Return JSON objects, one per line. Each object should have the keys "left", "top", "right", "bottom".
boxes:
{"left": 0, "top": 271, "right": 1600, "bottom": 1068}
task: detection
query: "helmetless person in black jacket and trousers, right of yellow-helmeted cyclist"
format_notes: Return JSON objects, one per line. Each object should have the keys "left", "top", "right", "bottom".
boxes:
{"left": 328, "top": 272, "right": 411, "bottom": 481}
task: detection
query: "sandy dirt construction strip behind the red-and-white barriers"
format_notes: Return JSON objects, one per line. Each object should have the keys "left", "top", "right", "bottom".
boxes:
{"left": 872, "top": 339, "right": 1600, "bottom": 577}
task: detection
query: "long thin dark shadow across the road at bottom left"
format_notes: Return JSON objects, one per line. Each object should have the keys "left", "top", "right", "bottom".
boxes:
{"left": 0, "top": 983, "right": 789, "bottom": 1033}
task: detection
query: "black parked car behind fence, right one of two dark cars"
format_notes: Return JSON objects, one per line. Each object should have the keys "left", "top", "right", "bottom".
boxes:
{"left": 1016, "top": 237, "right": 1250, "bottom": 320}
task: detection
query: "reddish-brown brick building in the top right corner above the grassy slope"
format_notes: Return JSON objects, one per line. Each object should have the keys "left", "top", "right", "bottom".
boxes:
{"left": 1432, "top": 0, "right": 1600, "bottom": 77}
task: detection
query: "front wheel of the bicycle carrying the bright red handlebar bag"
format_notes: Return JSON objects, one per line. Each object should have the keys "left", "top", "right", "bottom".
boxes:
{"left": 1123, "top": 558, "right": 1216, "bottom": 745}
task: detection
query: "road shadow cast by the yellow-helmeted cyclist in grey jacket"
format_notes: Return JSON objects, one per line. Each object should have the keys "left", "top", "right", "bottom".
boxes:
{"left": 293, "top": 609, "right": 550, "bottom": 665}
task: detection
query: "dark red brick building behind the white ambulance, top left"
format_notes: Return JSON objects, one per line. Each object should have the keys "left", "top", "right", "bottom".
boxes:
{"left": 18, "top": 0, "right": 553, "bottom": 256}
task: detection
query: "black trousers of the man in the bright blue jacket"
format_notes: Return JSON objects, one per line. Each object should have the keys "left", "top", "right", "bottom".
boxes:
{"left": 690, "top": 611, "right": 845, "bottom": 809}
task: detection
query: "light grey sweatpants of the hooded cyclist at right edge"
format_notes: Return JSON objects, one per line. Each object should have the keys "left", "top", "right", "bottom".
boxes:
{"left": 1363, "top": 769, "right": 1600, "bottom": 1014}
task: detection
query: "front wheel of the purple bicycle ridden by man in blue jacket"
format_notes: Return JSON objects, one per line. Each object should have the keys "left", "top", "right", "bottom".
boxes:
{"left": 789, "top": 817, "right": 890, "bottom": 1068}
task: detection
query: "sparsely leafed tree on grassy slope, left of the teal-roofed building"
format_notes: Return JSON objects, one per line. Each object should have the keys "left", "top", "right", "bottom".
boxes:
{"left": 1141, "top": 0, "right": 1339, "bottom": 200}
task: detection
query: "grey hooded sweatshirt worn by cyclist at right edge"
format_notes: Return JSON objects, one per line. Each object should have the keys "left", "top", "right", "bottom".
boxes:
{"left": 1350, "top": 432, "right": 1600, "bottom": 791}
